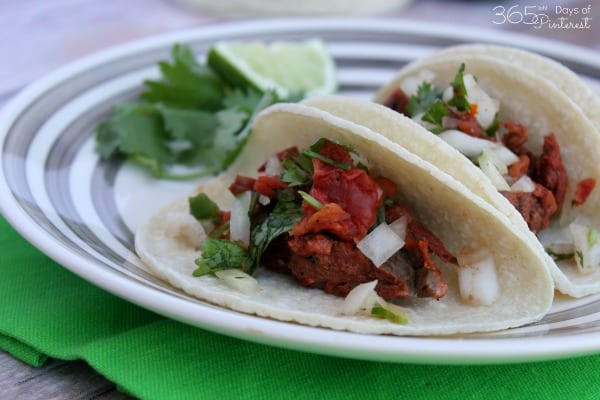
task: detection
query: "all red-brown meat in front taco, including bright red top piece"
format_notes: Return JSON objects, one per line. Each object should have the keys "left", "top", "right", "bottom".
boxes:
{"left": 261, "top": 142, "right": 457, "bottom": 300}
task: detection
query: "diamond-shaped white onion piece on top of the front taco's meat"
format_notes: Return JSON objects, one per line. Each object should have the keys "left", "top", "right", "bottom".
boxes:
{"left": 356, "top": 222, "right": 404, "bottom": 267}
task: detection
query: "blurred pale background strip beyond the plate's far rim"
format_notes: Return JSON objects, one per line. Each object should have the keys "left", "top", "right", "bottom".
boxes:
{"left": 0, "top": 0, "right": 600, "bottom": 106}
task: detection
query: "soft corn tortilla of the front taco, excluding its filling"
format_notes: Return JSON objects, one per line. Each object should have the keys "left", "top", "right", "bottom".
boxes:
{"left": 135, "top": 104, "right": 554, "bottom": 335}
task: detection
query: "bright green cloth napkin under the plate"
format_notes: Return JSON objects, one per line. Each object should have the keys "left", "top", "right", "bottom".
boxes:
{"left": 0, "top": 218, "right": 600, "bottom": 400}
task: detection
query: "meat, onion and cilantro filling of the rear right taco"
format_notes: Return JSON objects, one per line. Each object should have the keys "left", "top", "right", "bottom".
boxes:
{"left": 384, "top": 63, "right": 600, "bottom": 272}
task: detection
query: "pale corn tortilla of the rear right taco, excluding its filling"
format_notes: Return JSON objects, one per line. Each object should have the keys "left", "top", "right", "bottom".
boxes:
{"left": 358, "top": 54, "right": 600, "bottom": 297}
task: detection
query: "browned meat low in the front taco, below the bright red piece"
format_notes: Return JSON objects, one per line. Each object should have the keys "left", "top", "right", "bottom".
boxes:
{"left": 262, "top": 204, "right": 457, "bottom": 300}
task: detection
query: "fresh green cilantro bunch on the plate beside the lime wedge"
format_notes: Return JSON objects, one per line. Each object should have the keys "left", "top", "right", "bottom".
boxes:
{"left": 96, "top": 44, "right": 286, "bottom": 179}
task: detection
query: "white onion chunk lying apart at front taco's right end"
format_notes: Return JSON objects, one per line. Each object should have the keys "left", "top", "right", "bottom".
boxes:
{"left": 457, "top": 249, "right": 500, "bottom": 305}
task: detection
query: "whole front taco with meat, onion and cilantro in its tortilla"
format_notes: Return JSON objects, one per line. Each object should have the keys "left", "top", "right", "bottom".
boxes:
{"left": 135, "top": 104, "right": 554, "bottom": 335}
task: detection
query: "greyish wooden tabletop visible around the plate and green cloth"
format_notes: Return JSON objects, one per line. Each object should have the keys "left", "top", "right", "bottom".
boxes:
{"left": 0, "top": 0, "right": 600, "bottom": 400}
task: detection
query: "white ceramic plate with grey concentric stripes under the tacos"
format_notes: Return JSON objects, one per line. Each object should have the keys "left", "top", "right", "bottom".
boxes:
{"left": 0, "top": 19, "right": 600, "bottom": 363}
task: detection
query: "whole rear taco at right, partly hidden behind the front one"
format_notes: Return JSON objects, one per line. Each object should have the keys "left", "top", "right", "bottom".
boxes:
{"left": 347, "top": 49, "right": 600, "bottom": 297}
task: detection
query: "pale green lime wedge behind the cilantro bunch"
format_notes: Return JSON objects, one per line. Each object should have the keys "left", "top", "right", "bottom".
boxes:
{"left": 208, "top": 39, "right": 337, "bottom": 98}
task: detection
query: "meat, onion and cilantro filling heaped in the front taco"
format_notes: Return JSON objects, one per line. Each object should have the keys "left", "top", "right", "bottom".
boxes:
{"left": 190, "top": 139, "right": 458, "bottom": 306}
